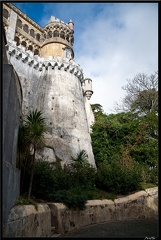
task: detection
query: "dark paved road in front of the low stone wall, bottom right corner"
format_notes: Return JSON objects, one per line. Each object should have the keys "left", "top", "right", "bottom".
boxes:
{"left": 59, "top": 219, "right": 159, "bottom": 240}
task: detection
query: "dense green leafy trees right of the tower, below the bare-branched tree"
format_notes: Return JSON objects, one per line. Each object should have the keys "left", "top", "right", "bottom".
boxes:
{"left": 91, "top": 108, "right": 158, "bottom": 183}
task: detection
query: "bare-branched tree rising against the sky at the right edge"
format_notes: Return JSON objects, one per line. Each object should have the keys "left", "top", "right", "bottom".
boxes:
{"left": 115, "top": 72, "right": 158, "bottom": 115}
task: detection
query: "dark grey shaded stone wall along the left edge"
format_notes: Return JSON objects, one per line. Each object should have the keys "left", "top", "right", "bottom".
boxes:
{"left": 2, "top": 26, "right": 22, "bottom": 229}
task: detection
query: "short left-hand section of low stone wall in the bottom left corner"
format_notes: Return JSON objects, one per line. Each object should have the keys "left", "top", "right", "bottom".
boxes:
{"left": 4, "top": 204, "right": 51, "bottom": 237}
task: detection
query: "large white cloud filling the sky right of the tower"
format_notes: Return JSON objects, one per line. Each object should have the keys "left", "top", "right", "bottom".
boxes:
{"left": 75, "top": 3, "right": 158, "bottom": 113}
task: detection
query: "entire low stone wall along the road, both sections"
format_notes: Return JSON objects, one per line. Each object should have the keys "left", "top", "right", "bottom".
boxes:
{"left": 4, "top": 187, "right": 158, "bottom": 237}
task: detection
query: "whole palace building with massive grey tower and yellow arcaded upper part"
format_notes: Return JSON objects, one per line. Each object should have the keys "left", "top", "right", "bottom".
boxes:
{"left": 3, "top": 3, "right": 95, "bottom": 166}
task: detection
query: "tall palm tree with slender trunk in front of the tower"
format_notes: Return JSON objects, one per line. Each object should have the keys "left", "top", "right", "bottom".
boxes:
{"left": 21, "top": 109, "right": 46, "bottom": 198}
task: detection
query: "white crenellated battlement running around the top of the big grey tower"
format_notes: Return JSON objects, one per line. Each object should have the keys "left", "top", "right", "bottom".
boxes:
{"left": 6, "top": 41, "right": 84, "bottom": 82}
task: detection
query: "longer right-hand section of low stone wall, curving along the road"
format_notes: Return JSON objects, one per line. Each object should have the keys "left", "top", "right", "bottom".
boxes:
{"left": 48, "top": 187, "right": 158, "bottom": 234}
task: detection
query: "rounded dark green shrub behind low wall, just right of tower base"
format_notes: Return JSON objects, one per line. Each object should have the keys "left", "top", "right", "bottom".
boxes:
{"left": 96, "top": 161, "right": 141, "bottom": 194}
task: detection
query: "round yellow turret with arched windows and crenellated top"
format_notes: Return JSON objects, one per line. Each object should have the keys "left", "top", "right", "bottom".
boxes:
{"left": 40, "top": 16, "right": 74, "bottom": 59}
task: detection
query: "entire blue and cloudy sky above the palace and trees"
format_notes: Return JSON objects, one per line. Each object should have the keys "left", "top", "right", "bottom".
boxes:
{"left": 14, "top": 2, "right": 158, "bottom": 114}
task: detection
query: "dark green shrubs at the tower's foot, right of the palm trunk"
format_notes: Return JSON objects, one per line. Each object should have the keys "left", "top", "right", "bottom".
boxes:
{"left": 28, "top": 159, "right": 96, "bottom": 200}
